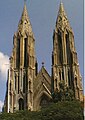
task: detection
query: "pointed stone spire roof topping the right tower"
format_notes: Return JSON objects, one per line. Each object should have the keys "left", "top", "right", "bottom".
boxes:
{"left": 56, "top": 2, "right": 71, "bottom": 30}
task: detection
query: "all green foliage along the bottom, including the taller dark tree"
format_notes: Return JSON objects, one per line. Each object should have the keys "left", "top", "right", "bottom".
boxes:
{"left": 0, "top": 82, "right": 84, "bottom": 120}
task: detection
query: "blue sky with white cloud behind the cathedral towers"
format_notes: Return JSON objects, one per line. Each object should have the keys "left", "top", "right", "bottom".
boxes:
{"left": 0, "top": 0, "right": 84, "bottom": 111}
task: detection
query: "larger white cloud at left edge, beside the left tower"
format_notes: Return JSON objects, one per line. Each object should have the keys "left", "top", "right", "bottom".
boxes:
{"left": 0, "top": 52, "right": 9, "bottom": 79}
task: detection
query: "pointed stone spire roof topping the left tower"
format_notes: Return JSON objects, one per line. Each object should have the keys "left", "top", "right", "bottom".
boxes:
{"left": 18, "top": 3, "right": 33, "bottom": 35}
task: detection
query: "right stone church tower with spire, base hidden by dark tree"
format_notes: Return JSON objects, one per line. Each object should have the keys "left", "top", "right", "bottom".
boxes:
{"left": 52, "top": 3, "right": 83, "bottom": 100}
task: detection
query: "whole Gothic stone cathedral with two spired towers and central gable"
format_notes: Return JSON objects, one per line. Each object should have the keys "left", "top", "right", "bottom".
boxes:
{"left": 3, "top": 2, "right": 83, "bottom": 113}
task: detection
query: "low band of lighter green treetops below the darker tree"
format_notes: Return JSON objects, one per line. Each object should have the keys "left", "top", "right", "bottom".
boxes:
{"left": 0, "top": 101, "right": 84, "bottom": 120}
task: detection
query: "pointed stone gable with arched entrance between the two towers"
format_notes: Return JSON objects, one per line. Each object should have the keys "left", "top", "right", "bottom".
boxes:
{"left": 33, "top": 68, "right": 51, "bottom": 110}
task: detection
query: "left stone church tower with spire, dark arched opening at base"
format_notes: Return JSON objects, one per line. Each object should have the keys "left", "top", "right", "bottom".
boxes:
{"left": 4, "top": 4, "right": 36, "bottom": 112}
